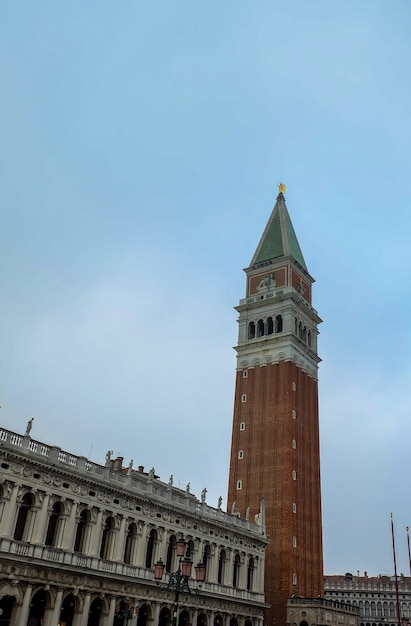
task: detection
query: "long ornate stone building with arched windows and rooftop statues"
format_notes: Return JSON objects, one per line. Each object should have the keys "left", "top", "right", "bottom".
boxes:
{"left": 0, "top": 428, "right": 267, "bottom": 626}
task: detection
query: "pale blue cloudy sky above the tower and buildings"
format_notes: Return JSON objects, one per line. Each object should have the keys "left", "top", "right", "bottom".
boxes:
{"left": 0, "top": 0, "right": 411, "bottom": 574}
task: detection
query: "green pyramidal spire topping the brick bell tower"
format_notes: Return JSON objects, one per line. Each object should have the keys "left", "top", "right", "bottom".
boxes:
{"left": 251, "top": 192, "right": 308, "bottom": 271}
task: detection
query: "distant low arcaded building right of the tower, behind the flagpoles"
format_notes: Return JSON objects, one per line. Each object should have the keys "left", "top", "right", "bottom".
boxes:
{"left": 324, "top": 572, "right": 411, "bottom": 626}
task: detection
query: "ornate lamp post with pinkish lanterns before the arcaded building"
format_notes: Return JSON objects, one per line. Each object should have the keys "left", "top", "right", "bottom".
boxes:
{"left": 154, "top": 539, "right": 205, "bottom": 626}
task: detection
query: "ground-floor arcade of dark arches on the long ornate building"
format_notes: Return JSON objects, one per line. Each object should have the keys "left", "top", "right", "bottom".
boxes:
{"left": 0, "top": 579, "right": 262, "bottom": 626}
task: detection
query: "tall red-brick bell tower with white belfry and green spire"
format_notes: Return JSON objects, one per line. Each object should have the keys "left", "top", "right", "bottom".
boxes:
{"left": 228, "top": 185, "right": 324, "bottom": 626}
